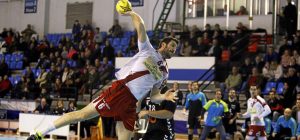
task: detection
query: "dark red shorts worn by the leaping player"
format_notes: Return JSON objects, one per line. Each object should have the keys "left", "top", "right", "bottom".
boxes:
{"left": 93, "top": 80, "right": 137, "bottom": 131}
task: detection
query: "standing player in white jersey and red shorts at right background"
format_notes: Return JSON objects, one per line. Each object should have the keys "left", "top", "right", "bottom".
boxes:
{"left": 238, "top": 86, "right": 271, "bottom": 140}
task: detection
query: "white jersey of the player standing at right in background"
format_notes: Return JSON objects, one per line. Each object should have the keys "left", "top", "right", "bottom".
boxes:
{"left": 243, "top": 96, "right": 271, "bottom": 126}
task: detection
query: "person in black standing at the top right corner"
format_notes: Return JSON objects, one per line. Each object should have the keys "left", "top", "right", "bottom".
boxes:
{"left": 283, "top": 0, "right": 297, "bottom": 36}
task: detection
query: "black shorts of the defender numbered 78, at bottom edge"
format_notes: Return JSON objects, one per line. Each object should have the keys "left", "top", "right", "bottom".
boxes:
{"left": 142, "top": 130, "right": 174, "bottom": 140}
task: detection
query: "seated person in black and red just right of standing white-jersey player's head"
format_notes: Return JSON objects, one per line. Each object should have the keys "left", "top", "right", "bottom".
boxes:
{"left": 267, "top": 91, "right": 283, "bottom": 122}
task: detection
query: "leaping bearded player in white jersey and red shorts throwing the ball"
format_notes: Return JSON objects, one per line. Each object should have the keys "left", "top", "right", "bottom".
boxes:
{"left": 28, "top": 1, "right": 178, "bottom": 140}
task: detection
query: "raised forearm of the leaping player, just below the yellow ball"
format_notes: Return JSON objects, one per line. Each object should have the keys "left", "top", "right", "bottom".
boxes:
{"left": 129, "top": 11, "right": 146, "bottom": 42}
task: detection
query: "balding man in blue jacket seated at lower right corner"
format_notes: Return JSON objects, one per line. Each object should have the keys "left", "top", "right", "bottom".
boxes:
{"left": 272, "top": 108, "right": 297, "bottom": 140}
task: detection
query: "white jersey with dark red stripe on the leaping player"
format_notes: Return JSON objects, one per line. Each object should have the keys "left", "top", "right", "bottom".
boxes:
{"left": 115, "top": 37, "right": 169, "bottom": 100}
